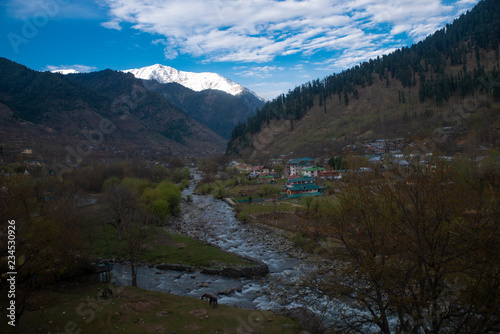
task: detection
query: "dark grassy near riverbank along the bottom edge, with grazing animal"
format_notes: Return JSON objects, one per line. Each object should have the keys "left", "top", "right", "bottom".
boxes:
{"left": 0, "top": 283, "right": 300, "bottom": 334}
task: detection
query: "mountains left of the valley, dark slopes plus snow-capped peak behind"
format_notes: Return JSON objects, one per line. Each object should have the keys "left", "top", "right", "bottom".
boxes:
{"left": 0, "top": 58, "right": 270, "bottom": 162}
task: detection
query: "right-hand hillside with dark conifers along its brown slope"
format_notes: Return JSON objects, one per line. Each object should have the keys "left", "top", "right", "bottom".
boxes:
{"left": 227, "top": 0, "right": 500, "bottom": 159}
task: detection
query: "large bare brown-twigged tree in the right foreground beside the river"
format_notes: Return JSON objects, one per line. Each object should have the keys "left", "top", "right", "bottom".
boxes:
{"left": 308, "top": 164, "right": 500, "bottom": 333}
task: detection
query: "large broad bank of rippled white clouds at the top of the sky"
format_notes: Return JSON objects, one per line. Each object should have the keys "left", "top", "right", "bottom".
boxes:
{"left": 101, "top": 0, "right": 478, "bottom": 62}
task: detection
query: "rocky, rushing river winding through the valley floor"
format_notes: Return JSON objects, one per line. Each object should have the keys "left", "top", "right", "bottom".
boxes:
{"left": 113, "top": 174, "right": 354, "bottom": 330}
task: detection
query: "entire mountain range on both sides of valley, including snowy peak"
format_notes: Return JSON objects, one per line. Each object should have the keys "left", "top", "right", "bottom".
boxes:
{"left": 0, "top": 0, "right": 500, "bottom": 164}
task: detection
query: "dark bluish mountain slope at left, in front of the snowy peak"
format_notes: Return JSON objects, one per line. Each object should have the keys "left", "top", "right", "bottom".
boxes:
{"left": 0, "top": 58, "right": 224, "bottom": 159}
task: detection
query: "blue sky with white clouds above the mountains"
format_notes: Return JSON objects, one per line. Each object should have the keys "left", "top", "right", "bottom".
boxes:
{"left": 0, "top": 0, "right": 478, "bottom": 100}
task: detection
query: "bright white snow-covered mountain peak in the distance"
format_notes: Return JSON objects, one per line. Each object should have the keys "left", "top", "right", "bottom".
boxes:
{"left": 123, "top": 64, "right": 265, "bottom": 101}
